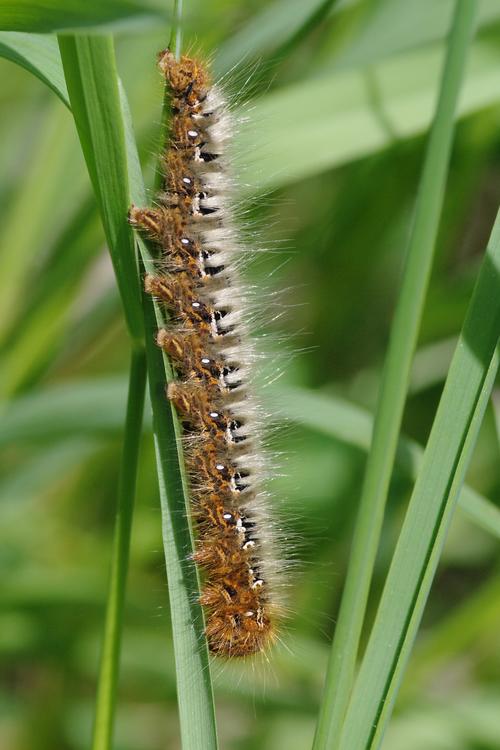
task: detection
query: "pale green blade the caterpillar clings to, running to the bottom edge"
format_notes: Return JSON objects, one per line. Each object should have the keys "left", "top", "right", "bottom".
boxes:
{"left": 144, "top": 290, "right": 217, "bottom": 750}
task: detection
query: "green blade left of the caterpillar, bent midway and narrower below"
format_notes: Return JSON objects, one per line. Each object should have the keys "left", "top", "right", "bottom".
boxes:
{"left": 59, "top": 30, "right": 146, "bottom": 750}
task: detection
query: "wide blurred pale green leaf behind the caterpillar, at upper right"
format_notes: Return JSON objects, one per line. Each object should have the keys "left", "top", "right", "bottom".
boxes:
{"left": 237, "top": 43, "right": 500, "bottom": 191}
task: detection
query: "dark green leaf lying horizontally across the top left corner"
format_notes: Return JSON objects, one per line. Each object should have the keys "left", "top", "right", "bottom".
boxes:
{"left": 0, "top": 0, "right": 169, "bottom": 33}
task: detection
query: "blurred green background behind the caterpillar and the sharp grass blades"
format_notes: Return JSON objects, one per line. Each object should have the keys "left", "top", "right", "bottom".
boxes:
{"left": 0, "top": 0, "right": 500, "bottom": 750}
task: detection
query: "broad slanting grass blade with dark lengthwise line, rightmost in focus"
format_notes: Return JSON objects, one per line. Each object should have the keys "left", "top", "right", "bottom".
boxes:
{"left": 340, "top": 212, "right": 500, "bottom": 750}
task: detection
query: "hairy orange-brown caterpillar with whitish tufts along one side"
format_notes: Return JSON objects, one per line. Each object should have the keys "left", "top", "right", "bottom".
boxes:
{"left": 129, "top": 50, "right": 281, "bottom": 656}
